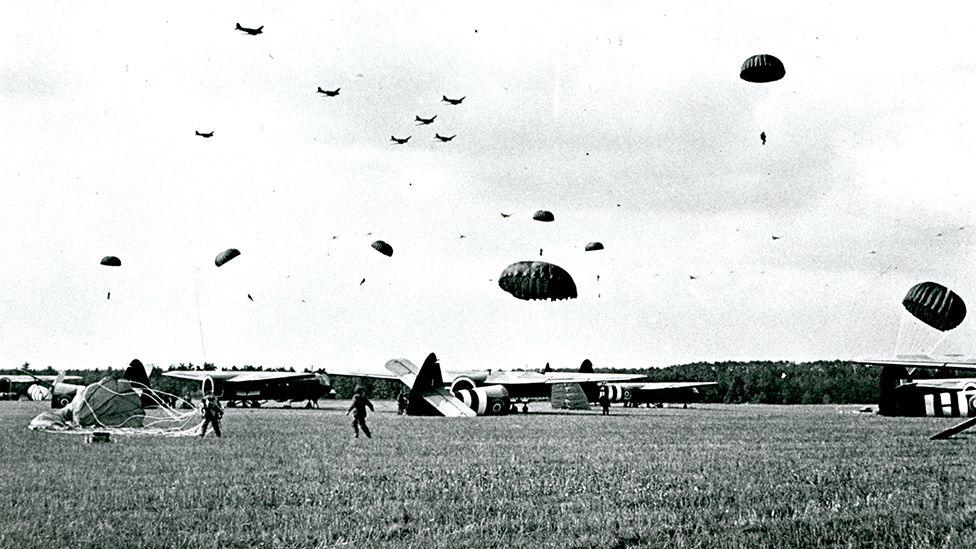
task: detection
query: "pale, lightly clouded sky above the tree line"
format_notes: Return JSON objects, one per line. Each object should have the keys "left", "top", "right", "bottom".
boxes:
{"left": 0, "top": 1, "right": 976, "bottom": 371}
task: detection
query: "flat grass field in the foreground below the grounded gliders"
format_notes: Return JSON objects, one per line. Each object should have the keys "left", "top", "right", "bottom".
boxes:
{"left": 0, "top": 401, "right": 976, "bottom": 549}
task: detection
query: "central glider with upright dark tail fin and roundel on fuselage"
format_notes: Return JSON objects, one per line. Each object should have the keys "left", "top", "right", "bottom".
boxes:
{"left": 344, "top": 353, "right": 642, "bottom": 417}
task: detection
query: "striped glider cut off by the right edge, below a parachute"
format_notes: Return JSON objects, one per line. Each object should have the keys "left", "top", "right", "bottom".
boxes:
{"left": 854, "top": 355, "right": 976, "bottom": 439}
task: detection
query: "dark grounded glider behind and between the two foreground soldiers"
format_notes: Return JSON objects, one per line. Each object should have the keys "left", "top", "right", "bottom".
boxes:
{"left": 163, "top": 370, "right": 335, "bottom": 408}
